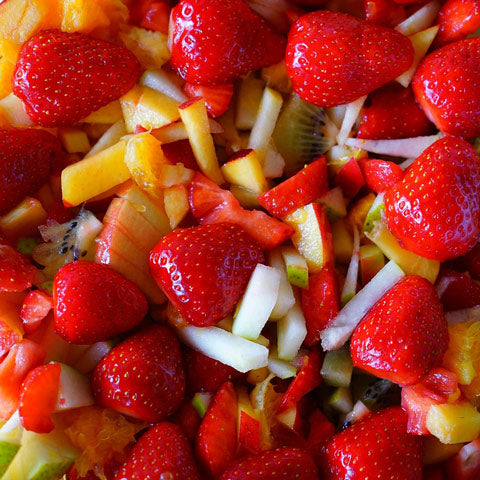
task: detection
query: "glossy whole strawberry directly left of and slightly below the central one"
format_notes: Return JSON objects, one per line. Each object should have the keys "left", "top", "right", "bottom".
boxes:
{"left": 53, "top": 261, "right": 148, "bottom": 344}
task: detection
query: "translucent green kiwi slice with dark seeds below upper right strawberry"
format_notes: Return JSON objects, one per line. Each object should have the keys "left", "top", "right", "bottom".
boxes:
{"left": 273, "top": 94, "right": 338, "bottom": 175}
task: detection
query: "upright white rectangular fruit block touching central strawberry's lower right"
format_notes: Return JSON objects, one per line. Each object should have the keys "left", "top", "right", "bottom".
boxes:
{"left": 232, "top": 263, "right": 280, "bottom": 340}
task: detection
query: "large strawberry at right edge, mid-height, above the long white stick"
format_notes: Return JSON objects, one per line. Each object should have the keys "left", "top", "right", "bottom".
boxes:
{"left": 385, "top": 137, "right": 480, "bottom": 261}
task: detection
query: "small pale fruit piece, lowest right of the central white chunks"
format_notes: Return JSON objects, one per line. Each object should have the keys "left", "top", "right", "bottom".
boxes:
{"left": 277, "top": 303, "right": 307, "bottom": 361}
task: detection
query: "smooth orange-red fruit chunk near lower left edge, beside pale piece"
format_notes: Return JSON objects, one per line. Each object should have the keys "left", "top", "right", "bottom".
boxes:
{"left": 18, "top": 363, "right": 62, "bottom": 433}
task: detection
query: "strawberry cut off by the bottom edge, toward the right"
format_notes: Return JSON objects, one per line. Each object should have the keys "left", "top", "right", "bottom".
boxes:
{"left": 323, "top": 407, "right": 422, "bottom": 480}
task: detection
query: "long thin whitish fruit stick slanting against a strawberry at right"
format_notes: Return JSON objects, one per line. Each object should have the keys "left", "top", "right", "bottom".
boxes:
{"left": 320, "top": 261, "right": 405, "bottom": 351}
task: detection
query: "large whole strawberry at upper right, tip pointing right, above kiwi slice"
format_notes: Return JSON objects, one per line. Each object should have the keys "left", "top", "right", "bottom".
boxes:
{"left": 286, "top": 11, "right": 413, "bottom": 107}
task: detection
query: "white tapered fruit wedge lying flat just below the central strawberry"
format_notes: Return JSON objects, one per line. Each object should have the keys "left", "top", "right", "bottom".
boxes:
{"left": 178, "top": 325, "right": 268, "bottom": 373}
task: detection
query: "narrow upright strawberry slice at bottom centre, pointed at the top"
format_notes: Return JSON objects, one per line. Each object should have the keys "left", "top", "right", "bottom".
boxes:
{"left": 195, "top": 382, "right": 237, "bottom": 478}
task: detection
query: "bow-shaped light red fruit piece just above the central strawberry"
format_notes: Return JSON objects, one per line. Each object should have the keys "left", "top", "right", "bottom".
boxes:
{"left": 188, "top": 173, "right": 294, "bottom": 250}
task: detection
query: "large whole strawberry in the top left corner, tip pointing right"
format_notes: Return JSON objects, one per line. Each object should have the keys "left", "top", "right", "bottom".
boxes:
{"left": 13, "top": 30, "right": 141, "bottom": 127}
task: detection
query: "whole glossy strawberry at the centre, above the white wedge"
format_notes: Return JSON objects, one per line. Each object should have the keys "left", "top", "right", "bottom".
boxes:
{"left": 150, "top": 223, "right": 264, "bottom": 327}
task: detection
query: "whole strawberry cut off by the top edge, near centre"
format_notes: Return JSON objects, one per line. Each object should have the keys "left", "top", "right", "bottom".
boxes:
{"left": 171, "top": 0, "right": 285, "bottom": 86}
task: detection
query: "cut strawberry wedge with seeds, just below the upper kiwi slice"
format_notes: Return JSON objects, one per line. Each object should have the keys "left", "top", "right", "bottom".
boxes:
{"left": 258, "top": 157, "right": 328, "bottom": 217}
